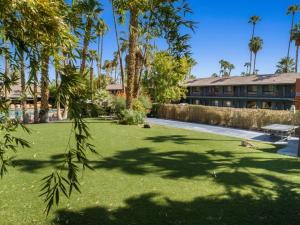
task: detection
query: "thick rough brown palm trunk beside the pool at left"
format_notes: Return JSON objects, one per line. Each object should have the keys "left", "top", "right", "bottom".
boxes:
{"left": 40, "top": 49, "right": 49, "bottom": 123}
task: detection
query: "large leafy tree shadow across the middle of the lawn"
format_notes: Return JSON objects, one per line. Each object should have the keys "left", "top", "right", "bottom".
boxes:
{"left": 92, "top": 148, "right": 216, "bottom": 179}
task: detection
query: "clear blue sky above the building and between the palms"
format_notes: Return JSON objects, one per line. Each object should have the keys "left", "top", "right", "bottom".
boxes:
{"left": 95, "top": 0, "right": 300, "bottom": 77}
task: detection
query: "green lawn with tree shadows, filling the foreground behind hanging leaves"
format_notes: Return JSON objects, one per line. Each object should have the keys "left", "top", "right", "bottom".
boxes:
{"left": 0, "top": 121, "right": 300, "bottom": 225}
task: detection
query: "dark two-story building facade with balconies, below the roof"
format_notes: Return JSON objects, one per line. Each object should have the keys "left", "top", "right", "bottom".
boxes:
{"left": 186, "top": 83, "right": 300, "bottom": 110}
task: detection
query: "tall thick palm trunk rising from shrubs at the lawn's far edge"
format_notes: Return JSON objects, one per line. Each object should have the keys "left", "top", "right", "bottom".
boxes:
{"left": 126, "top": 7, "right": 138, "bottom": 109}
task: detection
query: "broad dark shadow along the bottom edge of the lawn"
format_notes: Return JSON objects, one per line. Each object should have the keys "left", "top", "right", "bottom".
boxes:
{"left": 52, "top": 187, "right": 300, "bottom": 225}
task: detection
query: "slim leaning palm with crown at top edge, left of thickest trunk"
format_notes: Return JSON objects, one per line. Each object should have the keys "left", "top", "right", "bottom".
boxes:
{"left": 78, "top": 0, "right": 102, "bottom": 76}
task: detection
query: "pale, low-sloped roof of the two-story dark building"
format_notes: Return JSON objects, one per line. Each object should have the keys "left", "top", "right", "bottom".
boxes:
{"left": 186, "top": 73, "right": 300, "bottom": 87}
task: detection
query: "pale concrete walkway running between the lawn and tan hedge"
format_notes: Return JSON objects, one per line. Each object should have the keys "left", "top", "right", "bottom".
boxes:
{"left": 147, "top": 118, "right": 299, "bottom": 156}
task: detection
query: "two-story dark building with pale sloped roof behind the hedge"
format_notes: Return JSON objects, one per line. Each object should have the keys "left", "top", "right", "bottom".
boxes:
{"left": 186, "top": 73, "right": 300, "bottom": 110}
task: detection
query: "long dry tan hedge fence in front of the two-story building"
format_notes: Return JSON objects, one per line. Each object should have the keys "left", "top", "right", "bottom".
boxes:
{"left": 156, "top": 104, "right": 300, "bottom": 130}
